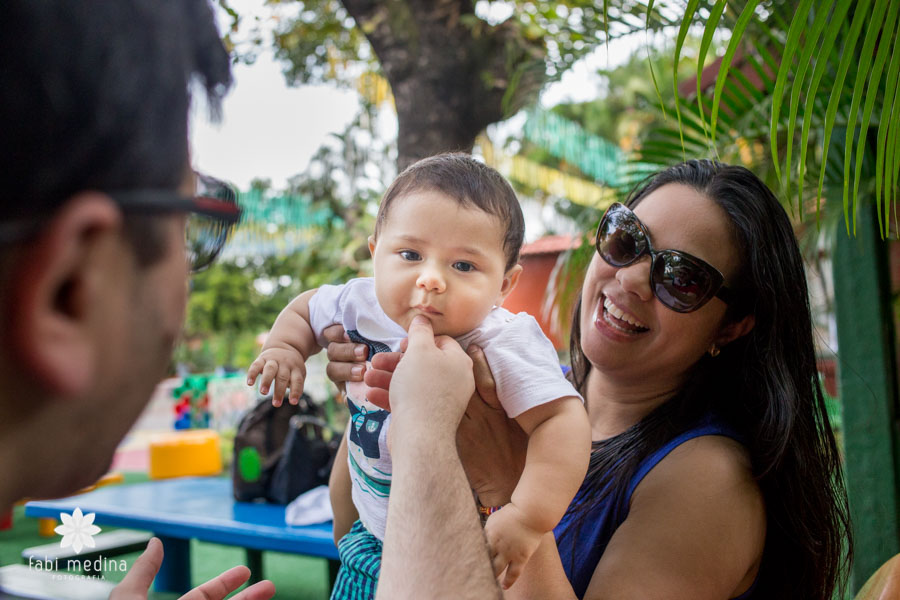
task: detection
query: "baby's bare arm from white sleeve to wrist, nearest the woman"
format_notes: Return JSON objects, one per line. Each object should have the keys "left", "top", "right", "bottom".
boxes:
{"left": 512, "top": 396, "right": 591, "bottom": 532}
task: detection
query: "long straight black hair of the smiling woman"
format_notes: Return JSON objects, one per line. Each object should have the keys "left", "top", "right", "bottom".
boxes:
{"left": 570, "top": 160, "right": 853, "bottom": 600}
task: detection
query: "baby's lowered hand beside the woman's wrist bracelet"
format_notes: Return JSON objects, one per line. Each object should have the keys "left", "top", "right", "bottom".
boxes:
{"left": 484, "top": 503, "right": 546, "bottom": 590}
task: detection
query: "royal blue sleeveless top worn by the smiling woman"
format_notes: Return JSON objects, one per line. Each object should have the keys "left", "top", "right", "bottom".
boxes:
{"left": 553, "top": 415, "right": 756, "bottom": 600}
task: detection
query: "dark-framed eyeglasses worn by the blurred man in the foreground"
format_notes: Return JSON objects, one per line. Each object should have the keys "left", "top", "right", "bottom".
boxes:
{"left": 0, "top": 173, "right": 241, "bottom": 273}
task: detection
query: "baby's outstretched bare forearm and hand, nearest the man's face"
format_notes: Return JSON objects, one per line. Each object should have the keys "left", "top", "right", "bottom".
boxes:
{"left": 247, "top": 290, "right": 320, "bottom": 406}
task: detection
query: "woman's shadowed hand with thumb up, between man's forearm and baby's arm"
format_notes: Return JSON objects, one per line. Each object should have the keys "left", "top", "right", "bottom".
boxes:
{"left": 456, "top": 345, "right": 528, "bottom": 506}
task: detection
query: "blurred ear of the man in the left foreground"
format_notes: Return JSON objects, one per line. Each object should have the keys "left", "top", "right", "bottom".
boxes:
{"left": 9, "top": 192, "right": 121, "bottom": 396}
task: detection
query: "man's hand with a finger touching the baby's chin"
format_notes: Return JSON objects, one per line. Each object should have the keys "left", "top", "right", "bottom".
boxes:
{"left": 390, "top": 316, "right": 475, "bottom": 438}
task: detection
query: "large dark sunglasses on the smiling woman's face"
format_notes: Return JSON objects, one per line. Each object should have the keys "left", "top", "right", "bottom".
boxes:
{"left": 597, "top": 202, "right": 734, "bottom": 313}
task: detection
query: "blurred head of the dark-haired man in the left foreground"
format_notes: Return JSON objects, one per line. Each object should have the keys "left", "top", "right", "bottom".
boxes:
{"left": 0, "top": 0, "right": 231, "bottom": 504}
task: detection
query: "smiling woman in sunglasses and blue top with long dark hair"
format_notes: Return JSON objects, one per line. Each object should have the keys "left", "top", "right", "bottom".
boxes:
{"left": 472, "top": 161, "right": 852, "bottom": 600}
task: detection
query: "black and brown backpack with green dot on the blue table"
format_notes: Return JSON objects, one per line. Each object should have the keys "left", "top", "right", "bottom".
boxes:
{"left": 231, "top": 394, "right": 340, "bottom": 504}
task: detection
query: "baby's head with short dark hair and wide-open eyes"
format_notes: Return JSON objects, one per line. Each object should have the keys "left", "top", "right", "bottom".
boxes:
{"left": 369, "top": 154, "right": 524, "bottom": 336}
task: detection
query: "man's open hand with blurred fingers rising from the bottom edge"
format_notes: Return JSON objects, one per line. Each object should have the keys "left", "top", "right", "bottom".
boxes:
{"left": 109, "top": 538, "right": 275, "bottom": 600}
